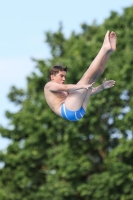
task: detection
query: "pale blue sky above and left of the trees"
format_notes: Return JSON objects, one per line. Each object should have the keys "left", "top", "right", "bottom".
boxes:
{"left": 0, "top": 0, "right": 133, "bottom": 150}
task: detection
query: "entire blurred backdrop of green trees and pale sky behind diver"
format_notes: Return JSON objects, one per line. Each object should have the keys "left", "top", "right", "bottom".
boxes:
{"left": 0, "top": 0, "right": 133, "bottom": 200}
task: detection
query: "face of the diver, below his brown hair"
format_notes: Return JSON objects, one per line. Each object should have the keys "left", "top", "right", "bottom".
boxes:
{"left": 51, "top": 71, "right": 66, "bottom": 84}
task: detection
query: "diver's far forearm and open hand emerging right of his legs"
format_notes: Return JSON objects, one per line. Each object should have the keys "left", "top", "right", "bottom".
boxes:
{"left": 91, "top": 78, "right": 115, "bottom": 95}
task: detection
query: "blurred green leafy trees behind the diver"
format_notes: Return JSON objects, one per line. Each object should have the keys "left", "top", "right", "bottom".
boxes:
{"left": 0, "top": 7, "right": 133, "bottom": 200}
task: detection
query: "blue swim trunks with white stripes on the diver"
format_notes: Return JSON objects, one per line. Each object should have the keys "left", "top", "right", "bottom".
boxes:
{"left": 61, "top": 103, "right": 85, "bottom": 121}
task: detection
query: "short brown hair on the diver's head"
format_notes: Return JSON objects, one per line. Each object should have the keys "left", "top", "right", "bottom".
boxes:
{"left": 49, "top": 65, "right": 68, "bottom": 80}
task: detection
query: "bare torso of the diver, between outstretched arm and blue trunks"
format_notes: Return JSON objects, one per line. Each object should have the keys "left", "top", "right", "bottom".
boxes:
{"left": 44, "top": 85, "right": 68, "bottom": 116}
